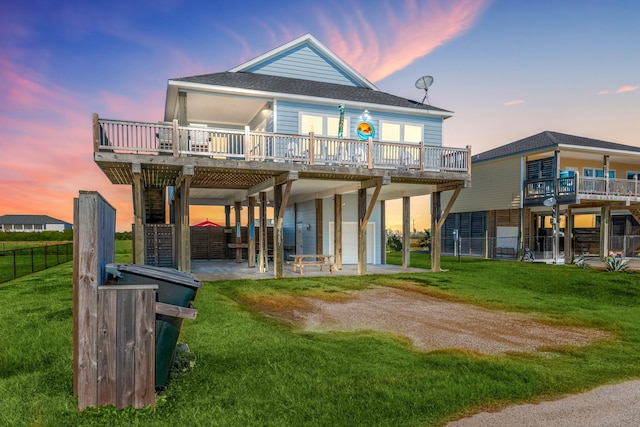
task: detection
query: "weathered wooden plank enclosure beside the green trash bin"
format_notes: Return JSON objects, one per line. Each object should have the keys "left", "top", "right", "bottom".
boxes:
{"left": 73, "top": 191, "right": 157, "bottom": 410}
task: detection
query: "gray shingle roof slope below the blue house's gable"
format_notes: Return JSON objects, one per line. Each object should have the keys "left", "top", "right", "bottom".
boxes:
{"left": 171, "top": 71, "right": 451, "bottom": 113}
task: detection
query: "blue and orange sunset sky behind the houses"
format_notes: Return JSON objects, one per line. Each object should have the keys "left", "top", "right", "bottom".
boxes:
{"left": 0, "top": 0, "right": 640, "bottom": 231}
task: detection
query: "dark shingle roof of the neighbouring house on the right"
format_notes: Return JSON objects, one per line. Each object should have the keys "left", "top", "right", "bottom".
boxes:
{"left": 471, "top": 131, "right": 640, "bottom": 163}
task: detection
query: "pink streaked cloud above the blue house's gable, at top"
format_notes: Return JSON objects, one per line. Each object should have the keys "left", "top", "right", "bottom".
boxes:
{"left": 317, "top": 0, "right": 489, "bottom": 82}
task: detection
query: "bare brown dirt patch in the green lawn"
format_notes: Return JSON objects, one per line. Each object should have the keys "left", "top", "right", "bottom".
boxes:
{"left": 265, "top": 287, "right": 610, "bottom": 355}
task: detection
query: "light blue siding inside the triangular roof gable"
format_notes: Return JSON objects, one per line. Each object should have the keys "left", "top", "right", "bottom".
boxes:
{"left": 246, "top": 45, "right": 361, "bottom": 86}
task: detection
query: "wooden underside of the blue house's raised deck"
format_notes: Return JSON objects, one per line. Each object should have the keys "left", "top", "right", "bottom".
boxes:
{"left": 96, "top": 154, "right": 469, "bottom": 206}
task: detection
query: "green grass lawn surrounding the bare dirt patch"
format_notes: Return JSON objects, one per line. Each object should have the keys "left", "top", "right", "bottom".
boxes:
{"left": 0, "top": 242, "right": 640, "bottom": 426}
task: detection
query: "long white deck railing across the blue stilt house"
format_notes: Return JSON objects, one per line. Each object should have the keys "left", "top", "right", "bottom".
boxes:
{"left": 93, "top": 115, "right": 471, "bottom": 173}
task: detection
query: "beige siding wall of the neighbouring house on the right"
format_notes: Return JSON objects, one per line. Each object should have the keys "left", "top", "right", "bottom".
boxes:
{"left": 442, "top": 157, "right": 521, "bottom": 213}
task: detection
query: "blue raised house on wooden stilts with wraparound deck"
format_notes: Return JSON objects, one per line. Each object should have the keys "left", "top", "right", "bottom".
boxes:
{"left": 93, "top": 34, "right": 471, "bottom": 277}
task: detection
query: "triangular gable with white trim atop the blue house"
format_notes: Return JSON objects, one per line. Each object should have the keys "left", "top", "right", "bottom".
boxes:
{"left": 229, "top": 34, "right": 378, "bottom": 90}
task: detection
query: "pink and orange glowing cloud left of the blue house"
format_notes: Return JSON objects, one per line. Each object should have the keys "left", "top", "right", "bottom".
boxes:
{"left": 0, "top": 59, "right": 138, "bottom": 230}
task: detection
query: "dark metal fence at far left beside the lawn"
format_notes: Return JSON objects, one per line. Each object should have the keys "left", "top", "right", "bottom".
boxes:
{"left": 0, "top": 243, "right": 73, "bottom": 283}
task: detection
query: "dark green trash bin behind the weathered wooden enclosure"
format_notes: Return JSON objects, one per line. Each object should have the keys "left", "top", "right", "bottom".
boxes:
{"left": 106, "top": 264, "right": 202, "bottom": 387}
